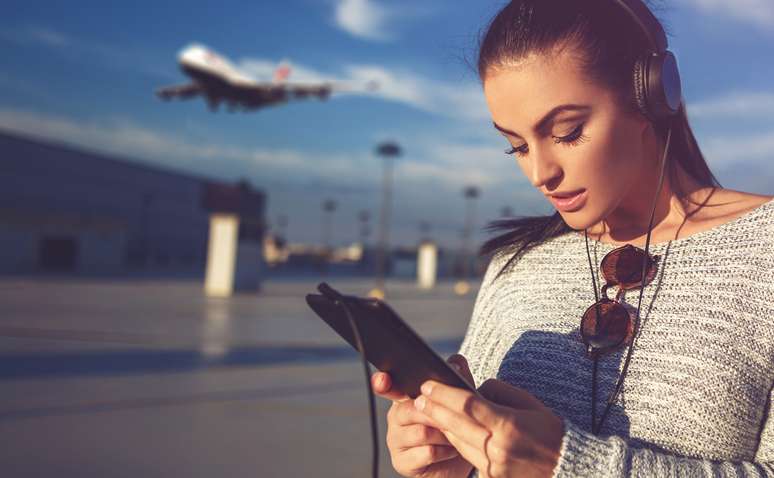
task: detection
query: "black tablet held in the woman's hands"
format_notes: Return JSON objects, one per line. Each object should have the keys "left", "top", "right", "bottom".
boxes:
{"left": 306, "top": 282, "right": 477, "bottom": 398}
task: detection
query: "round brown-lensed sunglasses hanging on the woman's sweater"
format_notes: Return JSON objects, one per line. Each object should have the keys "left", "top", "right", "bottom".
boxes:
{"left": 580, "top": 244, "right": 658, "bottom": 358}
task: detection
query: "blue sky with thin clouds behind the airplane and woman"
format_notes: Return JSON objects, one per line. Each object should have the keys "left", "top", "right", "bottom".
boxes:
{"left": 0, "top": 0, "right": 774, "bottom": 247}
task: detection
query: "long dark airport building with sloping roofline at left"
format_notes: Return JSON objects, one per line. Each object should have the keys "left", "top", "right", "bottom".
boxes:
{"left": 0, "top": 132, "right": 266, "bottom": 276}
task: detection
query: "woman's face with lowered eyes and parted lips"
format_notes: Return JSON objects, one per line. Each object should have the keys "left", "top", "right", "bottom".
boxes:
{"left": 484, "top": 49, "right": 654, "bottom": 230}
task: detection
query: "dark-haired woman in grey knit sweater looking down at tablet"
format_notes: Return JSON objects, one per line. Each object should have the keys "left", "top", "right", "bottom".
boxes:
{"left": 372, "top": 0, "right": 774, "bottom": 477}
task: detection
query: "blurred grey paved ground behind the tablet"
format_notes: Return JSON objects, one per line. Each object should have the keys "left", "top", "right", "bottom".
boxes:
{"left": 0, "top": 277, "right": 476, "bottom": 478}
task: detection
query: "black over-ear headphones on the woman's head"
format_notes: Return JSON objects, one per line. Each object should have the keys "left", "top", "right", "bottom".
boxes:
{"left": 615, "top": 0, "right": 683, "bottom": 122}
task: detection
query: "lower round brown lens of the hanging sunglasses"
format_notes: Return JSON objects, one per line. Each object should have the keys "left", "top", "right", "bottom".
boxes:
{"left": 580, "top": 299, "right": 633, "bottom": 352}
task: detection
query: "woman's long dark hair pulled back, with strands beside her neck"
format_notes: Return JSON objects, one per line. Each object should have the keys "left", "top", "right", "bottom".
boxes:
{"left": 478, "top": 0, "right": 720, "bottom": 277}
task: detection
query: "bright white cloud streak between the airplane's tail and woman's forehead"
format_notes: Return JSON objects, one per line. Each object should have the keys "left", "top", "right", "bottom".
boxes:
{"left": 238, "top": 58, "right": 489, "bottom": 121}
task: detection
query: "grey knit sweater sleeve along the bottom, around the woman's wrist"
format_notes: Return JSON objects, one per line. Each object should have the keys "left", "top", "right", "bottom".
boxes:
{"left": 553, "top": 395, "right": 774, "bottom": 478}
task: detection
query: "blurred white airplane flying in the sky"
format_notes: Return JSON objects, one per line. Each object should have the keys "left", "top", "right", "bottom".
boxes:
{"left": 156, "top": 44, "right": 378, "bottom": 111}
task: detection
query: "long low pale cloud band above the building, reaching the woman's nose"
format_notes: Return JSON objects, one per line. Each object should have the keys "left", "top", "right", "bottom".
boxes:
{"left": 0, "top": 108, "right": 516, "bottom": 189}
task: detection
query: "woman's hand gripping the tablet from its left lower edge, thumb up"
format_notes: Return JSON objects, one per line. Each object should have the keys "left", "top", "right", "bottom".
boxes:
{"left": 371, "top": 355, "right": 473, "bottom": 478}
